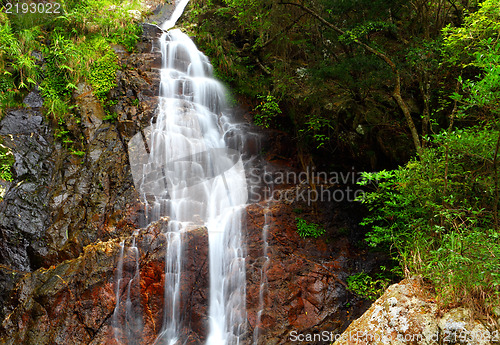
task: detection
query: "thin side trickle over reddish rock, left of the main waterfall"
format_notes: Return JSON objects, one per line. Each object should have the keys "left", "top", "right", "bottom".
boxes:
{"left": 111, "top": 232, "right": 143, "bottom": 345}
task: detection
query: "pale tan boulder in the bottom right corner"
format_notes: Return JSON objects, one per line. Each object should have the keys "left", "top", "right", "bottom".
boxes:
{"left": 335, "top": 278, "right": 494, "bottom": 345}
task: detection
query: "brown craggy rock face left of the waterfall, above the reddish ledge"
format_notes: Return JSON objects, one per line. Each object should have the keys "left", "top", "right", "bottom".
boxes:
{"left": 18, "top": 15, "right": 161, "bottom": 269}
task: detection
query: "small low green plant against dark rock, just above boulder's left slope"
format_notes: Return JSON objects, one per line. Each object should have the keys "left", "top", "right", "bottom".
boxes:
{"left": 346, "top": 272, "right": 390, "bottom": 301}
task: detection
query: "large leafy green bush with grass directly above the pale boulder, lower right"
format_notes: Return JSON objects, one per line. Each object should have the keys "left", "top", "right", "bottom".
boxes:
{"left": 361, "top": 128, "right": 500, "bottom": 302}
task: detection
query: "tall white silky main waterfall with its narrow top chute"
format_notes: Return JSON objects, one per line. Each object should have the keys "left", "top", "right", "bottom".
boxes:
{"left": 129, "top": 1, "right": 248, "bottom": 345}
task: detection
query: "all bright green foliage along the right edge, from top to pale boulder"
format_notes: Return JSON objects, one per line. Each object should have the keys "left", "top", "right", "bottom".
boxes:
{"left": 354, "top": 0, "right": 500, "bottom": 308}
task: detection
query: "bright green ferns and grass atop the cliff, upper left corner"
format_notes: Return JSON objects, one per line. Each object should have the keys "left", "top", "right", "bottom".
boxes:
{"left": 0, "top": 0, "right": 142, "bottom": 155}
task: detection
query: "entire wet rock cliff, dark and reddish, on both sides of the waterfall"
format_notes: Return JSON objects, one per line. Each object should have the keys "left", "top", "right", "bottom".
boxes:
{"left": 0, "top": 4, "right": 386, "bottom": 345}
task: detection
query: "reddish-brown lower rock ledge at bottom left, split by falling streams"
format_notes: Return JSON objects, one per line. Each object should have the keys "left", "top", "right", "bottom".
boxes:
{"left": 0, "top": 219, "right": 208, "bottom": 345}
